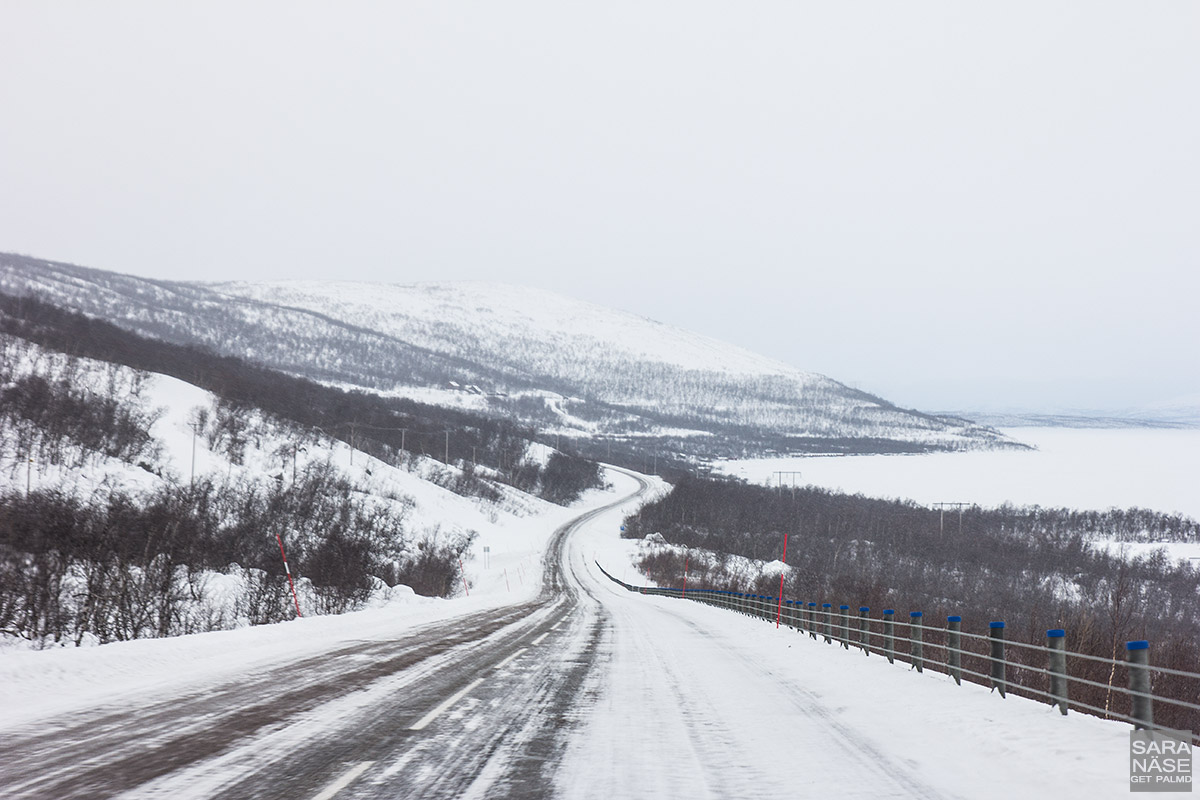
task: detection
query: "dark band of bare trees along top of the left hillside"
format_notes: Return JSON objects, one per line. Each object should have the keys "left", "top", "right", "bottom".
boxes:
{"left": 0, "top": 294, "right": 600, "bottom": 506}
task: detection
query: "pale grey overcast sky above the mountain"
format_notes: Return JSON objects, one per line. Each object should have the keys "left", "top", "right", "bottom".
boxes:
{"left": 0, "top": 0, "right": 1200, "bottom": 410}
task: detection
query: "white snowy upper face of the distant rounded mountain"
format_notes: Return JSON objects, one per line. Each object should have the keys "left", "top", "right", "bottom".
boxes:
{"left": 212, "top": 282, "right": 1012, "bottom": 444}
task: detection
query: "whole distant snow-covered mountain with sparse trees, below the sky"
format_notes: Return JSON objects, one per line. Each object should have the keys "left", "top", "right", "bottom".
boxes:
{"left": 0, "top": 254, "right": 1012, "bottom": 455}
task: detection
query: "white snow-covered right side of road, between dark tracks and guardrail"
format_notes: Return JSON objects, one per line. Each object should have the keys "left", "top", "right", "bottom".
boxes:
{"left": 566, "top": 515, "right": 1147, "bottom": 800}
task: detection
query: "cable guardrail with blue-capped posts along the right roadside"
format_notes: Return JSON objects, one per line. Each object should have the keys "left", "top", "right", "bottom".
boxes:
{"left": 596, "top": 563, "right": 1200, "bottom": 744}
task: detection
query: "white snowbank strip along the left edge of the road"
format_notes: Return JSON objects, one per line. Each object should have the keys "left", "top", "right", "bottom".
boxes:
{"left": 0, "top": 470, "right": 652, "bottom": 729}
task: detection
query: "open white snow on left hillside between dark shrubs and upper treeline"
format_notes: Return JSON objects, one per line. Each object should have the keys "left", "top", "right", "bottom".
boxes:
{"left": 0, "top": 328, "right": 600, "bottom": 646}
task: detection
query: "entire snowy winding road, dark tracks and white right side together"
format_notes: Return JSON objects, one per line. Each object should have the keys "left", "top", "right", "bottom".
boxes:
{"left": 0, "top": 473, "right": 1152, "bottom": 800}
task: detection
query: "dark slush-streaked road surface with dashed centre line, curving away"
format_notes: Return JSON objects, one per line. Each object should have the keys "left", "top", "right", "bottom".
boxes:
{"left": 0, "top": 470, "right": 648, "bottom": 800}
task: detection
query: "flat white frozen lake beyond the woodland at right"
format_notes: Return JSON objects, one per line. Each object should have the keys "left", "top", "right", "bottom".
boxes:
{"left": 716, "top": 428, "right": 1200, "bottom": 519}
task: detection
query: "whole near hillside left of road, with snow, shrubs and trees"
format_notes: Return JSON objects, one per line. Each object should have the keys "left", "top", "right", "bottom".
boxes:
{"left": 0, "top": 307, "right": 609, "bottom": 646}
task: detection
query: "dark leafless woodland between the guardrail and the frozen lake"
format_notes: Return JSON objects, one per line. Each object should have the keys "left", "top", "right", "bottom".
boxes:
{"left": 624, "top": 479, "right": 1200, "bottom": 729}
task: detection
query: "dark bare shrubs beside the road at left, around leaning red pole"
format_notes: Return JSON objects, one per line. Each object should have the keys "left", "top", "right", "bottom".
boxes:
{"left": 0, "top": 462, "right": 473, "bottom": 644}
